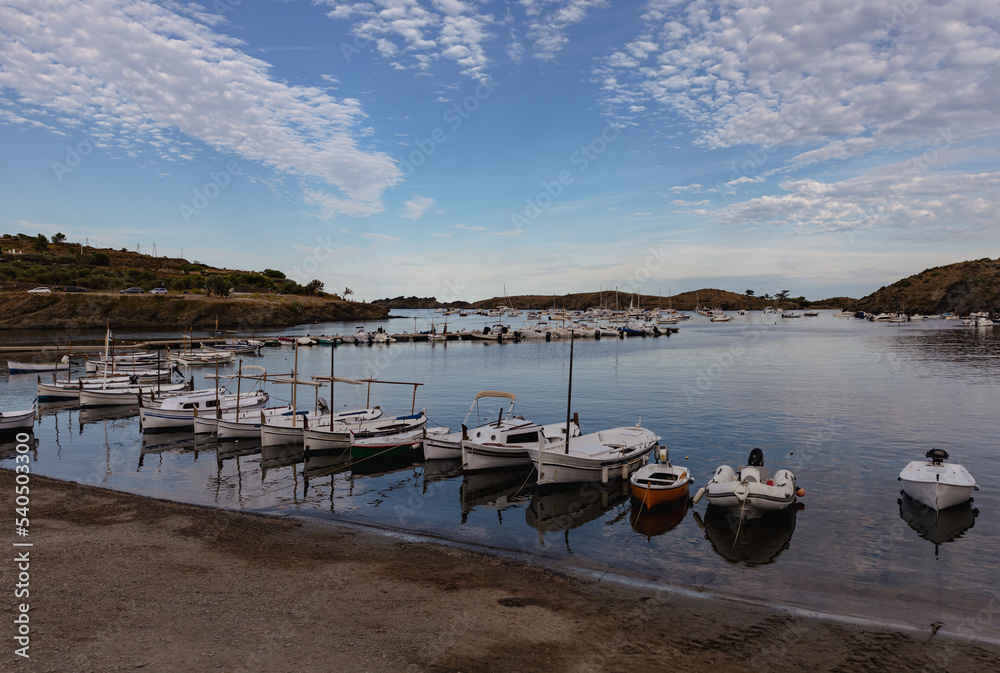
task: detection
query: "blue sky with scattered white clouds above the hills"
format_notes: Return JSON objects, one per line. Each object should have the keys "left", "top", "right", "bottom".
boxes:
{"left": 0, "top": 0, "right": 1000, "bottom": 301}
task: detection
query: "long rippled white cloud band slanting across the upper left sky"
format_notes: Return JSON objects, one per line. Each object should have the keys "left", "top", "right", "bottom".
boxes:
{"left": 0, "top": 0, "right": 400, "bottom": 215}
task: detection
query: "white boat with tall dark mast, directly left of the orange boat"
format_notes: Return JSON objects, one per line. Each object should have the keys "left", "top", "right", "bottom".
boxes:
{"left": 528, "top": 422, "right": 660, "bottom": 486}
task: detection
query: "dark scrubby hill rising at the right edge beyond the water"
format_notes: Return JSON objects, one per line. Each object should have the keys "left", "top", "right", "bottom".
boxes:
{"left": 850, "top": 257, "right": 1000, "bottom": 315}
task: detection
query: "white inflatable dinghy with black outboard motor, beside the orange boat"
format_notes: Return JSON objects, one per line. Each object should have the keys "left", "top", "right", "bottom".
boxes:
{"left": 695, "top": 449, "right": 805, "bottom": 519}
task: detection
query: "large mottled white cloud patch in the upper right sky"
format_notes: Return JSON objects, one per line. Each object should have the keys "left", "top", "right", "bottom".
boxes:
{"left": 595, "top": 0, "right": 1000, "bottom": 163}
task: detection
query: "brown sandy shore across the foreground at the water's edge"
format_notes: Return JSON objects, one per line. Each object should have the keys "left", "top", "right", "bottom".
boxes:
{"left": 0, "top": 470, "right": 1000, "bottom": 673}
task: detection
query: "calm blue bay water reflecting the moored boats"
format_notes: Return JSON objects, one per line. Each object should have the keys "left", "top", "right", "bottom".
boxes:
{"left": 0, "top": 311, "right": 1000, "bottom": 638}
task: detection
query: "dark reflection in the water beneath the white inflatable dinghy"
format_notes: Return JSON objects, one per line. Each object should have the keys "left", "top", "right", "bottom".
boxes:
{"left": 694, "top": 503, "right": 803, "bottom": 568}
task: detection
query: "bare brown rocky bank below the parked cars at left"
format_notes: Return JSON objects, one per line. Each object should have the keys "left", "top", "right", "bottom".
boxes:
{"left": 0, "top": 292, "right": 389, "bottom": 332}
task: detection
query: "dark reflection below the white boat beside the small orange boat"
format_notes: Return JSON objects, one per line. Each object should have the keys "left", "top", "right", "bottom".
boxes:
{"left": 524, "top": 479, "right": 630, "bottom": 533}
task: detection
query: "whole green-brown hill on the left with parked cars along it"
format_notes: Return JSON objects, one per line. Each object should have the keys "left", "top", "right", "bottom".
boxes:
{"left": 0, "top": 234, "right": 389, "bottom": 330}
